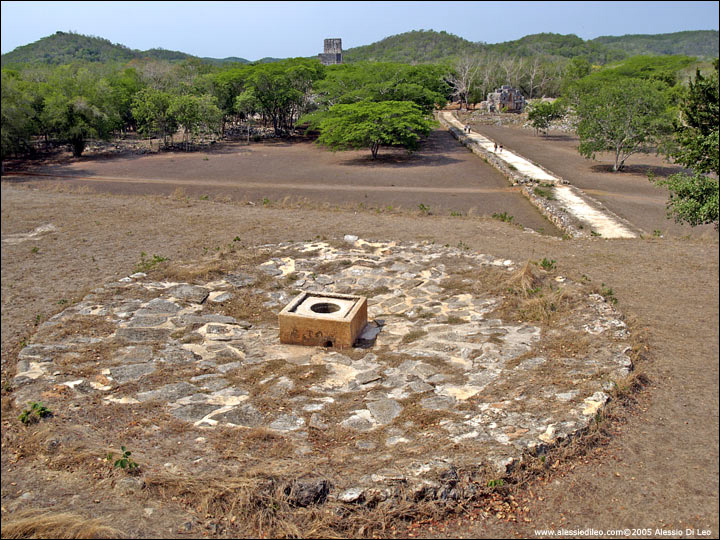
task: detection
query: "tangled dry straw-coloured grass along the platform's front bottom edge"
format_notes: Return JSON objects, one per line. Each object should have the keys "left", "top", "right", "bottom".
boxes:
{"left": 145, "top": 470, "right": 463, "bottom": 538}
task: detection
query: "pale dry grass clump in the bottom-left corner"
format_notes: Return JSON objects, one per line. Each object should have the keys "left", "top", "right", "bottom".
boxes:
{"left": 2, "top": 510, "right": 127, "bottom": 538}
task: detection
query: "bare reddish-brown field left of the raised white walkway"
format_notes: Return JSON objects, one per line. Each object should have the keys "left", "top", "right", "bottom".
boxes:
{"left": 1, "top": 130, "right": 561, "bottom": 235}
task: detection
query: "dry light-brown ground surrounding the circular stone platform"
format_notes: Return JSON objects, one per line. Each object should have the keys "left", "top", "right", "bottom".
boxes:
{"left": 2, "top": 184, "right": 718, "bottom": 537}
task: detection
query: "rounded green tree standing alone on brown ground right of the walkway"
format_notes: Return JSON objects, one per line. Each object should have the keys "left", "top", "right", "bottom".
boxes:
{"left": 577, "top": 79, "right": 671, "bottom": 172}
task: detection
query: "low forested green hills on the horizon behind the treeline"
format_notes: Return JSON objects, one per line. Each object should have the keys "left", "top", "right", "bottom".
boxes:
{"left": 2, "top": 30, "right": 718, "bottom": 66}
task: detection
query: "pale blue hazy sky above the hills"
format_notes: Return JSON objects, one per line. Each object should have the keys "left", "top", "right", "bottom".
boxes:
{"left": 0, "top": 1, "right": 718, "bottom": 60}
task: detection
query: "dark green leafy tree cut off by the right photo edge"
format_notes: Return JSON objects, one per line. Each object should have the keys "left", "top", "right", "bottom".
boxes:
{"left": 656, "top": 59, "right": 719, "bottom": 229}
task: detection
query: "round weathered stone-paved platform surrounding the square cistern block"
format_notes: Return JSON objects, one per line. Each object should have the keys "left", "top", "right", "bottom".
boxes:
{"left": 14, "top": 237, "right": 632, "bottom": 502}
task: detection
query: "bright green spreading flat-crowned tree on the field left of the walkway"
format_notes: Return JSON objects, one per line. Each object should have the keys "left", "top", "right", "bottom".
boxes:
{"left": 317, "top": 101, "right": 432, "bottom": 159}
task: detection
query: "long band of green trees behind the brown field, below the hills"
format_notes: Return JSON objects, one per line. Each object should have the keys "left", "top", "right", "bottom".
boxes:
{"left": 2, "top": 38, "right": 698, "bottom": 158}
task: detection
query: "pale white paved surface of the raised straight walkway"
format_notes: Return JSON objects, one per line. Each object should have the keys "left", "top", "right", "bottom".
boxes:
{"left": 440, "top": 112, "right": 637, "bottom": 238}
